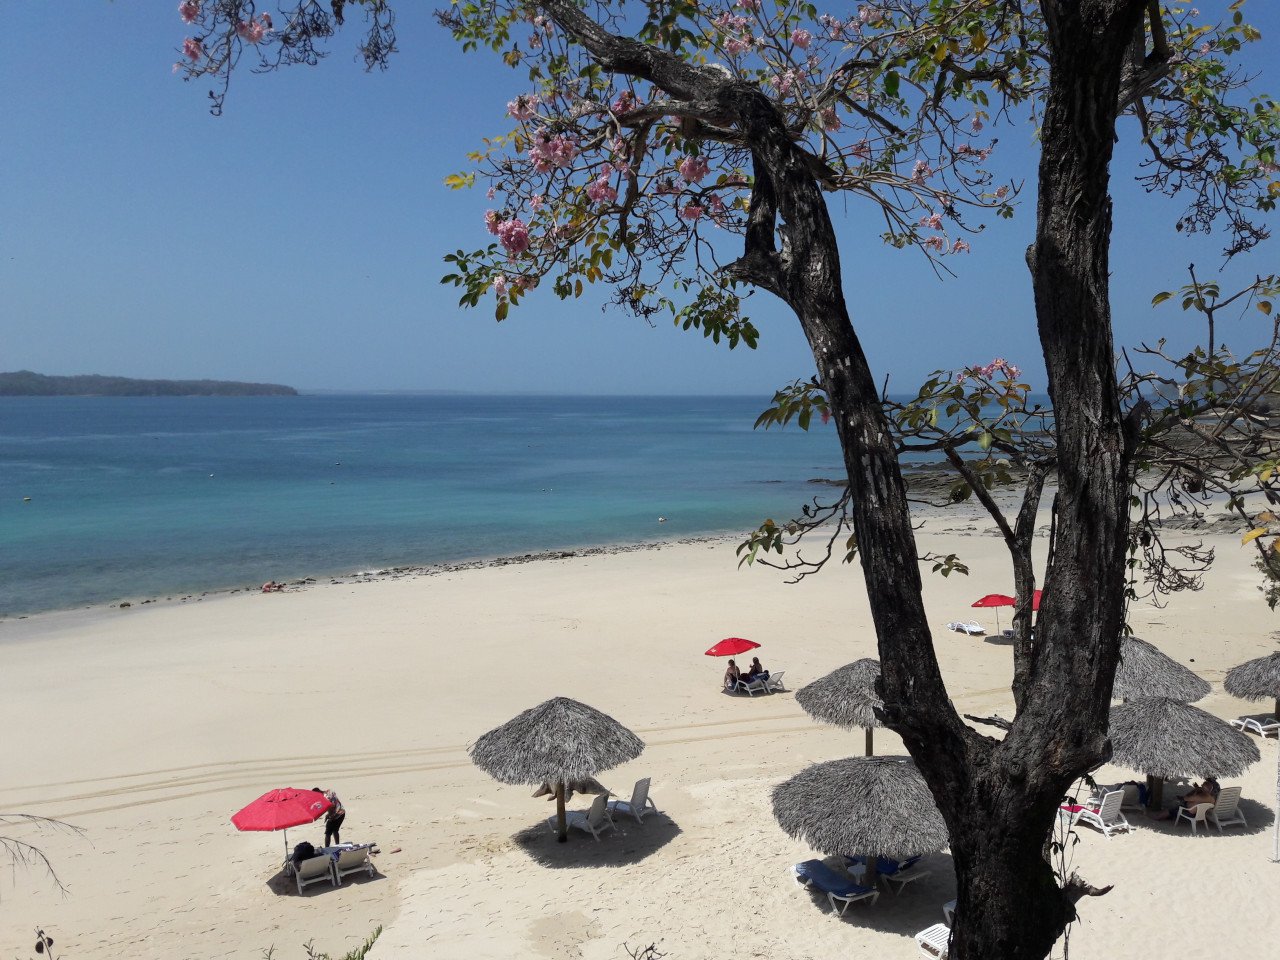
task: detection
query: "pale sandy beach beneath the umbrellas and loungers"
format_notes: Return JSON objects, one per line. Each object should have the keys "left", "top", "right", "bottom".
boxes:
{"left": 0, "top": 515, "right": 1280, "bottom": 960}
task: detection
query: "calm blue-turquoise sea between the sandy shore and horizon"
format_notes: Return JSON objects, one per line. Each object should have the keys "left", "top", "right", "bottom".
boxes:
{"left": 0, "top": 396, "right": 842, "bottom": 617}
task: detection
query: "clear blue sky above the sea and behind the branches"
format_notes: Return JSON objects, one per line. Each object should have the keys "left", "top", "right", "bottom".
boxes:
{"left": 0, "top": 0, "right": 1280, "bottom": 396}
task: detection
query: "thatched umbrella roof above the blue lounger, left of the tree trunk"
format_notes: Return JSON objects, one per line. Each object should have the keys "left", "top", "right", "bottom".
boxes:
{"left": 773, "top": 756, "right": 947, "bottom": 859}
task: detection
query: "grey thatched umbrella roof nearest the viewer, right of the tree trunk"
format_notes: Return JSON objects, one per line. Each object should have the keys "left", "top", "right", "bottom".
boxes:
{"left": 1111, "top": 696, "right": 1258, "bottom": 780}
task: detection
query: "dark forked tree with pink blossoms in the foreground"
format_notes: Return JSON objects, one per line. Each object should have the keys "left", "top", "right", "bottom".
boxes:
{"left": 172, "top": 0, "right": 1280, "bottom": 960}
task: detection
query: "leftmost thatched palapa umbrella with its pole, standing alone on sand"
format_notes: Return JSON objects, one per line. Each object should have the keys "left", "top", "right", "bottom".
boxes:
{"left": 468, "top": 696, "right": 644, "bottom": 842}
